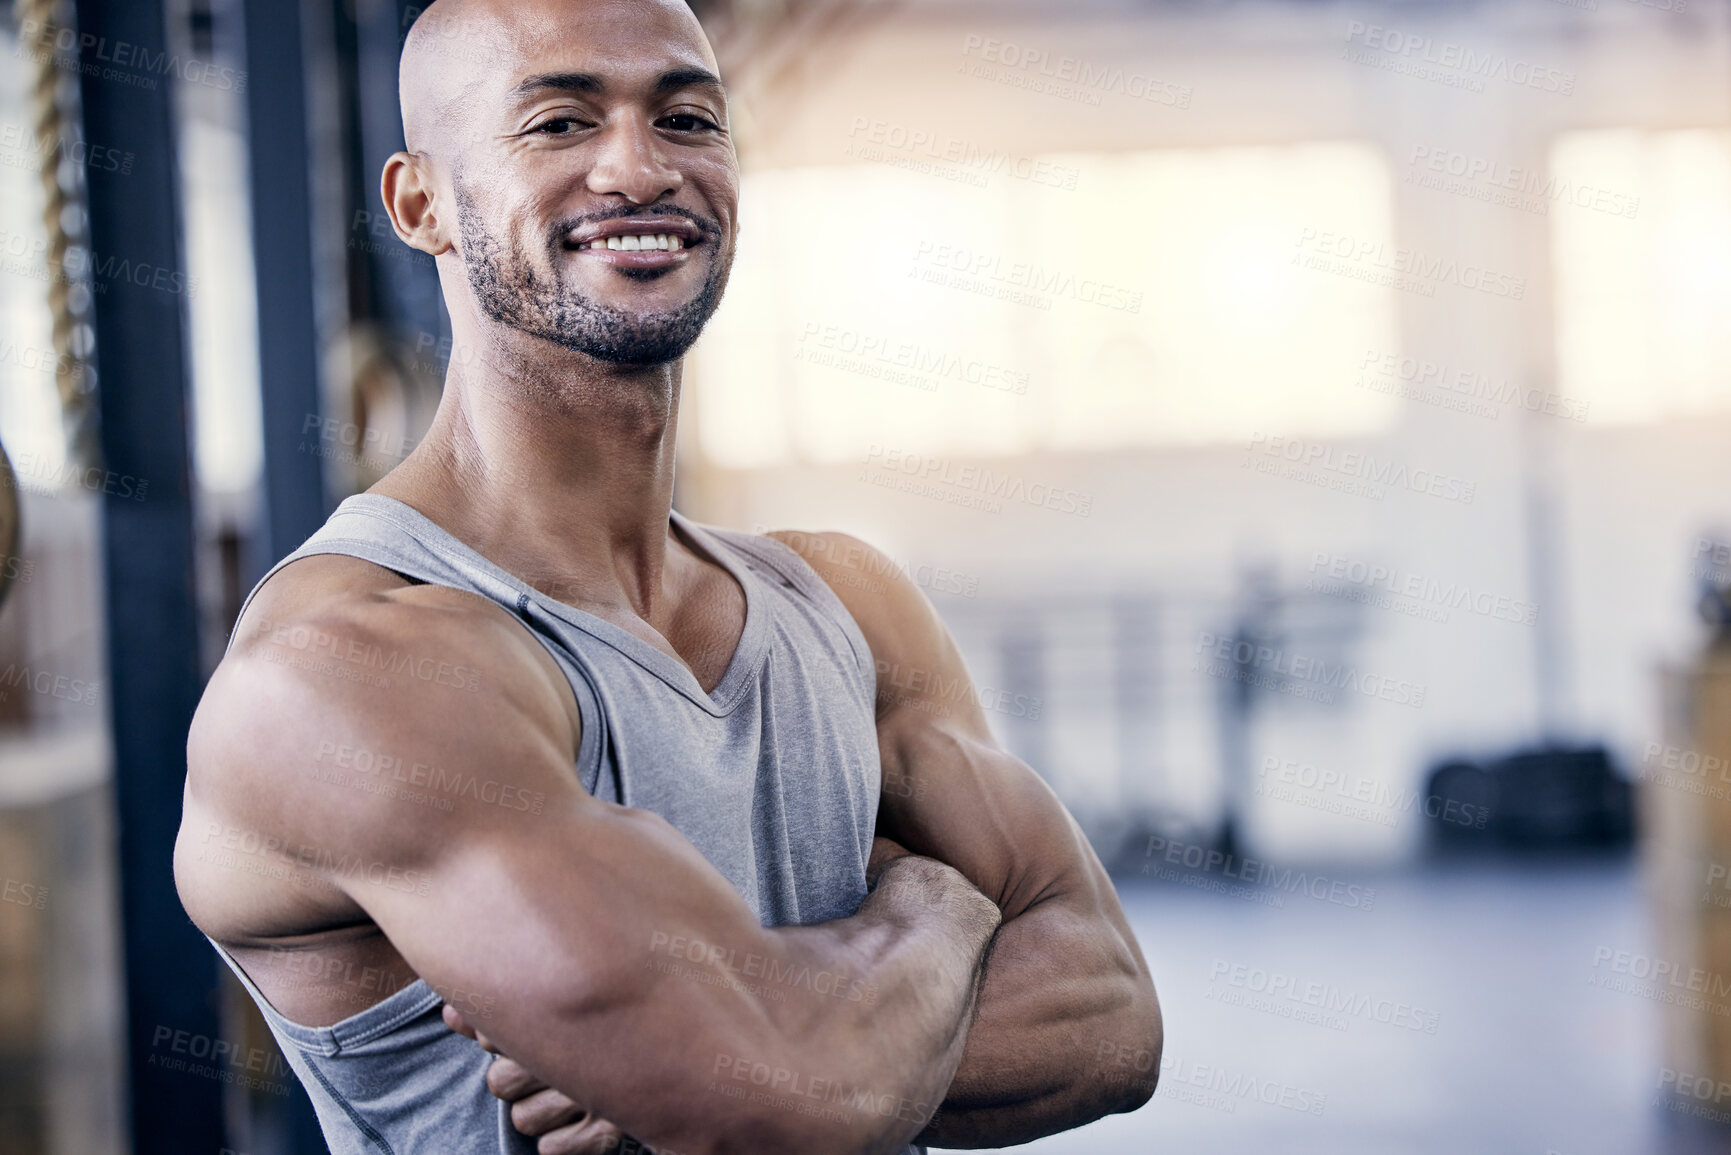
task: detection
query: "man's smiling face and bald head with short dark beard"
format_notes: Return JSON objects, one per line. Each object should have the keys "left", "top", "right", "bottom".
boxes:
{"left": 396, "top": 0, "right": 739, "bottom": 365}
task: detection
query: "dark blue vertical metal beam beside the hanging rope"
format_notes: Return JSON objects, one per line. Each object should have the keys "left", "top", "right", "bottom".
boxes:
{"left": 76, "top": 0, "right": 223, "bottom": 1155}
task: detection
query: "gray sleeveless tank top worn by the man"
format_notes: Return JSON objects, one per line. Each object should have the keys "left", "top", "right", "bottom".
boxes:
{"left": 211, "top": 494, "right": 924, "bottom": 1155}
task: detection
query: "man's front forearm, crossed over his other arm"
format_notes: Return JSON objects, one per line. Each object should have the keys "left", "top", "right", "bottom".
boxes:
{"left": 504, "top": 857, "right": 1001, "bottom": 1155}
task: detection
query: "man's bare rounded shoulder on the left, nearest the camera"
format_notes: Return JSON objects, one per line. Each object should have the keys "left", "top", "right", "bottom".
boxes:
{"left": 175, "top": 556, "right": 580, "bottom": 939}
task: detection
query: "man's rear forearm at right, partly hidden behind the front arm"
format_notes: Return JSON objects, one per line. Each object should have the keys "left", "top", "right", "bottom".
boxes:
{"left": 919, "top": 899, "right": 1160, "bottom": 1148}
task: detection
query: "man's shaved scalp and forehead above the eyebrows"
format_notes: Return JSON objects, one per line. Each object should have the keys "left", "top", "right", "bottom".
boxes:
{"left": 396, "top": 0, "right": 720, "bottom": 161}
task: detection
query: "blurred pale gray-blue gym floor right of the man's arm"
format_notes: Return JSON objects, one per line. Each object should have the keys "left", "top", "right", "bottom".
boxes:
{"left": 941, "top": 859, "right": 1724, "bottom": 1155}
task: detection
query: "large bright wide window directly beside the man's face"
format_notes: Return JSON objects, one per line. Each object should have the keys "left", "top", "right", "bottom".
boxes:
{"left": 691, "top": 144, "right": 1395, "bottom": 468}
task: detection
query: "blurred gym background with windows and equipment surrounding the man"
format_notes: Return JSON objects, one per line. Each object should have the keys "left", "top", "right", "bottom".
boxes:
{"left": 0, "top": 0, "right": 1731, "bottom": 1155}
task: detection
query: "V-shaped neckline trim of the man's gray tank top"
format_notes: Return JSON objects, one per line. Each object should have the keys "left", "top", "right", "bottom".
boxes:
{"left": 338, "top": 494, "right": 769, "bottom": 715}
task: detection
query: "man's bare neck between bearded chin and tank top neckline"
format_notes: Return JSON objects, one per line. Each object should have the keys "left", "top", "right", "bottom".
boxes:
{"left": 372, "top": 335, "right": 680, "bottom": 622}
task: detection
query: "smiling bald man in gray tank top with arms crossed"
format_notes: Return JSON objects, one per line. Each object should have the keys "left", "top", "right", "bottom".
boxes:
{"left": 175, "top": 0, "right": 1160, "bottom": 1155}
